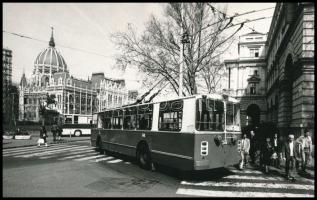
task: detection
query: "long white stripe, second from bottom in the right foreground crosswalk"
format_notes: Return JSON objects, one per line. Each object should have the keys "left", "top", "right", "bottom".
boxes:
{"left": 181, "top": 181, "right": 314, "bottom": 190}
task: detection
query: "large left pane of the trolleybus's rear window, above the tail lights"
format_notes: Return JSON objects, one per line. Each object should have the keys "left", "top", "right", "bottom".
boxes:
{"left": 196, "top": 98, "right": 224, "bottom": 131}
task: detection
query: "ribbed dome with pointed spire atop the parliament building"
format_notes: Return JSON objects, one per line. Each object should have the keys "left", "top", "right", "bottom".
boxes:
{"left": 33, "top": 29, "right": 67, "bottom": 75}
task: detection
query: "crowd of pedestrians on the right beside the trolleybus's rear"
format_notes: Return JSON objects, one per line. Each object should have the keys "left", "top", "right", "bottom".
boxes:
{"left": 239, "top": 129, "right": 312, "bottom": 180}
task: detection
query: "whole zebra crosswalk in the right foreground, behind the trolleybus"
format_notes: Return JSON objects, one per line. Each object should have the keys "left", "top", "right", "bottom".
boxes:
{"left": 176, "top": 166, "right": 315, "bottom": 197}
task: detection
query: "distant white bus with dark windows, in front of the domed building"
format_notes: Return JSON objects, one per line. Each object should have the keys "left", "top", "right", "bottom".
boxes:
{"left": 62, "top": 124, "right": 94, "bottom": 137}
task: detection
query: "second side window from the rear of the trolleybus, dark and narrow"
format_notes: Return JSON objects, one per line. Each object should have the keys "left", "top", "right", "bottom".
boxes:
{"left": 137, "top": 104, "right": 153, "bottom": 130}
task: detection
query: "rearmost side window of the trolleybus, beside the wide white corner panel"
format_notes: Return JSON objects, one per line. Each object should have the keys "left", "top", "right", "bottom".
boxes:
{"left": 158, "top": 100, "right": 183, "bottom": 131}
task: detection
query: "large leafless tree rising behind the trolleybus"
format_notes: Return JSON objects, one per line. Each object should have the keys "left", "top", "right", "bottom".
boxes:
{"left": 112, "top": 3, "right": 243, "bottom": 95}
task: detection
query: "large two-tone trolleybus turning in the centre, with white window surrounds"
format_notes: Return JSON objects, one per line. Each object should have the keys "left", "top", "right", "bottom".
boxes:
{"left": 91, "top": 94, "right": 241, "bottom": 171}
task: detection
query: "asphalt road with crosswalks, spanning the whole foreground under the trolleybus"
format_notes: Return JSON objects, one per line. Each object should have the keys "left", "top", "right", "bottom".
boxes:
{"left": 2, "top": 141, "right": 314, "bottom": 197}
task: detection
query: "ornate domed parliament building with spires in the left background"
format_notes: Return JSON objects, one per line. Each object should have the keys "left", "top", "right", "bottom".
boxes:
{"left": 19, "top": 29, "right": 128, "bottom": 124}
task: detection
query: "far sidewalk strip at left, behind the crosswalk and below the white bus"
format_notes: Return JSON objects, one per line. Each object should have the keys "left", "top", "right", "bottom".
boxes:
{"left": 2, "top": 134, "right": 90, "bottom": 149}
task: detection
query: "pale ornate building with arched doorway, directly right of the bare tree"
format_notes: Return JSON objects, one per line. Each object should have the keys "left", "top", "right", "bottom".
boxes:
{"left": 225, "top": 32, "right": 267, "bottom": 126}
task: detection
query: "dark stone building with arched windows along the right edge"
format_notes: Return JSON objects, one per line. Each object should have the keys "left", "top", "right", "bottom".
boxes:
{"left": 266, "top": 3, "right": 315, "bottom": 136}
